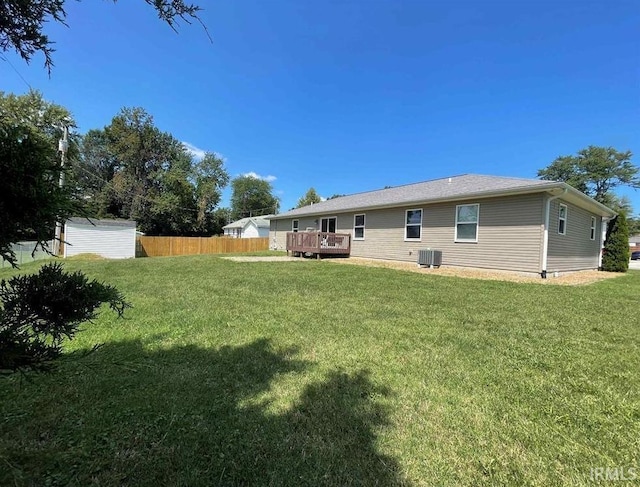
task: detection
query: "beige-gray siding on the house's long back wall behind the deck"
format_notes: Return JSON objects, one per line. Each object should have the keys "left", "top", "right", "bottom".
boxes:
{"left": 271, "top": 194, "right": 543, "bottom": 273}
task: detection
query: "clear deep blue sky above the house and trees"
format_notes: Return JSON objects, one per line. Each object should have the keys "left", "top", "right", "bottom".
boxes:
{"left": 0, "top": 0, "right": 640, "bottom": 213}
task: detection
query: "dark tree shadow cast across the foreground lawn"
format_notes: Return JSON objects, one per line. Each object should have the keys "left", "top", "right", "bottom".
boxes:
{"left": 0, "top": 340, "right": 408, "bottom": 487}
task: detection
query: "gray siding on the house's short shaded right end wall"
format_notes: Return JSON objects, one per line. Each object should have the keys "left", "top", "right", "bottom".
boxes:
{"left": 547, "top": 199, "right": 602, "bottom": 272}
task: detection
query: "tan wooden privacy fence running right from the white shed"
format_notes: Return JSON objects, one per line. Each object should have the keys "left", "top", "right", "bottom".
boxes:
{"left": 136, "top": 236, "right": 269, "bottom": 257}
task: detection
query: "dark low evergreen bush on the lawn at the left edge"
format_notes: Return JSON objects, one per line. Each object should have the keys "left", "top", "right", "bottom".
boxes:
{"left": 0, "top": 263, "right": 130, "bottom": 374}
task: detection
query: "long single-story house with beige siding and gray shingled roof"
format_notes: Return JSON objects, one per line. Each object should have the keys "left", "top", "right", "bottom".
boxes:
{"left": 270, "top": 174, "right": 615, "bottom": 277}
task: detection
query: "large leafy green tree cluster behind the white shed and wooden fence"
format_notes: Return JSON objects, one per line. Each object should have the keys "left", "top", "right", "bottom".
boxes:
{"left": 74, "top": 108, "right": 229, "bottom": 235}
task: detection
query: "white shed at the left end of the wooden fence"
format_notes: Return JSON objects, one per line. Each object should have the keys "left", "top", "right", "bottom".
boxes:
{"left": 64, "top": 218, "right": 136, "bottom": 259}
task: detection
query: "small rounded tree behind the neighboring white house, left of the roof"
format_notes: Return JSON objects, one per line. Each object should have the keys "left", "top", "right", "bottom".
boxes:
{"left": 231, "top": 175, "right": 280, "bottom": 220}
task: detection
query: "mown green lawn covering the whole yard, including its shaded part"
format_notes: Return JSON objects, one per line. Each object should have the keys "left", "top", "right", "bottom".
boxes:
{"left": 0, "top": 256, "right": 640, "bottom": 487}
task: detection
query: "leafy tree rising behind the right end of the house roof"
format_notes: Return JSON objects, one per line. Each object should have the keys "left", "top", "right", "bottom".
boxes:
{"left": 538, "top": 145, "right": 640, "bottom": 205}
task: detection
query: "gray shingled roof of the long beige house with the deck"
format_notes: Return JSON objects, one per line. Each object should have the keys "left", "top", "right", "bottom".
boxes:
{"left": 269, "top": 174, "right": 614, "bottom": 220}
